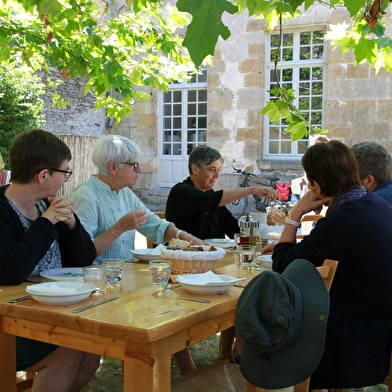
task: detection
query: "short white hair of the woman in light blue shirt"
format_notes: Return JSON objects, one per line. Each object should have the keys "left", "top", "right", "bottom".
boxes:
{"left": 92, "top": 135, "right": 143, "bottom": 176}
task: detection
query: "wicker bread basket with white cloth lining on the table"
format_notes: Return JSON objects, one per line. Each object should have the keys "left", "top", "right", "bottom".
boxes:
{"left": 161, "top": 247, "right": 226, "bottom": 275}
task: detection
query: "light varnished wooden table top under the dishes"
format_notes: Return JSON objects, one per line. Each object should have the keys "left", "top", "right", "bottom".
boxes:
{"left": 0, "top": 252, "right": 259, "bottom": 344}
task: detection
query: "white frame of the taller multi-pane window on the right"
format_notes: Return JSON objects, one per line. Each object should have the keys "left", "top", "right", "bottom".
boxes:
{"left": 263, "top": 26, "right": 326, "bottom": 160}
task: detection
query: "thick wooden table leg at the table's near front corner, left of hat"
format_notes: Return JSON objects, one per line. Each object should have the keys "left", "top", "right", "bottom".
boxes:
{"left": 123, "top": 338, "right": 171, "bottom": 392}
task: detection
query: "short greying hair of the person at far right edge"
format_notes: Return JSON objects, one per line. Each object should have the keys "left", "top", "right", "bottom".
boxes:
{"left": 351, "top": 142, "right": 392, "bottom": 185}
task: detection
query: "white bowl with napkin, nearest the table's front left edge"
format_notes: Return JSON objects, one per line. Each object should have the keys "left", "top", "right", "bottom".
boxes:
{"left": 26, "top": 282, "right": 96, "bottom": 305}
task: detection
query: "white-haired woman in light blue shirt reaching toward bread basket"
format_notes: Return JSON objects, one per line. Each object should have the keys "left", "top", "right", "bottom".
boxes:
{"left": 71, "top": 135, "right": 203, "bottom": 264}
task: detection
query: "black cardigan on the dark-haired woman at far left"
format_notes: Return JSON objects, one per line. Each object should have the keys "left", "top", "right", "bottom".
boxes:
{"left": 0, "top": 186, "right": 96, "bottom": 285}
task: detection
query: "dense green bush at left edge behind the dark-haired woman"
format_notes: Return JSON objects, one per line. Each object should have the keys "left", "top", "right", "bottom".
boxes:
{"left": 0, "top": 66, "right": 44, "bottom": 167}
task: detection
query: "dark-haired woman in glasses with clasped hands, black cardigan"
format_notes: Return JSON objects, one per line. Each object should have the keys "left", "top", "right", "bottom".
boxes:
{"left": 0, "top": 130, "right": 100, "bottom": 392}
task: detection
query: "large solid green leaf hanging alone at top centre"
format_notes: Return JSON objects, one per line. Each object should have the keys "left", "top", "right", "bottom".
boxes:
{"left": 177, "top": 0, "right": 238, "bottom": 68}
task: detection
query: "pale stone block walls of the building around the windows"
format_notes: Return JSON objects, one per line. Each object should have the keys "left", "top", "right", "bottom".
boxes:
{"left": 44, "top": 4, "right": 392, "bottom": 196}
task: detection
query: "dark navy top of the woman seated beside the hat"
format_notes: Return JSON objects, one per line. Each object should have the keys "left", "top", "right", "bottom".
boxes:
{"left": 273, "top": 193, "right": 392, "bottom": 389}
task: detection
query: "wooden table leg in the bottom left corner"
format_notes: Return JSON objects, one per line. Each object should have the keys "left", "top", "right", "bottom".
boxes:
{"left": 0, "top": 332, "right": 16, "bottom": 392}
